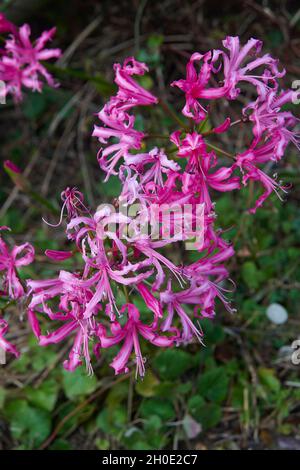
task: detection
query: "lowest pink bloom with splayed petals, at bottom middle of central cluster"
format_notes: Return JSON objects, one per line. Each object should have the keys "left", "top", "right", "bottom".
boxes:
{"left": 98, "top": 304, "right": 176, "bottom": 377}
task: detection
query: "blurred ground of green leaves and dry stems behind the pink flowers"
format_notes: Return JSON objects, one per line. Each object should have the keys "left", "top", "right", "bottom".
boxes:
{"left": 0, "top": 0, "right": 300, "bottom": 450}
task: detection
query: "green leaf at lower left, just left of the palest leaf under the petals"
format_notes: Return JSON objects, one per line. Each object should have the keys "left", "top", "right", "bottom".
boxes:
{"left": 26, "top": 379, "right": 59, "bottom": 411}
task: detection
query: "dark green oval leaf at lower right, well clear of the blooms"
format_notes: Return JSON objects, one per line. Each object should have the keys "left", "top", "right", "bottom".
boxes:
{"left": 198, "top": 367, "right": 229, "bottom": 403}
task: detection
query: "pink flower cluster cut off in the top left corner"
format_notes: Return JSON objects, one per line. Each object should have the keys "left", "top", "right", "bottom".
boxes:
{"left": 0, "top": 13, "right": 61, "bottom": 101}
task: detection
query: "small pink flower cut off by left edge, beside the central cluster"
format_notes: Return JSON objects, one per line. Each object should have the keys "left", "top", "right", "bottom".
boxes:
{"left": 0, "top": 228, "right": 34, "bottom": 299}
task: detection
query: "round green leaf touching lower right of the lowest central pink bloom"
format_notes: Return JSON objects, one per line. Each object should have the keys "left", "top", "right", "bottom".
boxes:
{"left": 153, "top": 349, "right": 193, "bottom": 380}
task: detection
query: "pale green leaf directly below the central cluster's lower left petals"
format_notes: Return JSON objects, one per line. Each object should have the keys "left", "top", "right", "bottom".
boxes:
{"left": 63, "top": 367, "right": 97, "bottom": 400}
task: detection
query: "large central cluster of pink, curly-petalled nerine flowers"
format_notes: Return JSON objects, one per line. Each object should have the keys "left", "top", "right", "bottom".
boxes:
{"left": 0, "top": 31, "right": 299, "bottom": 376}
